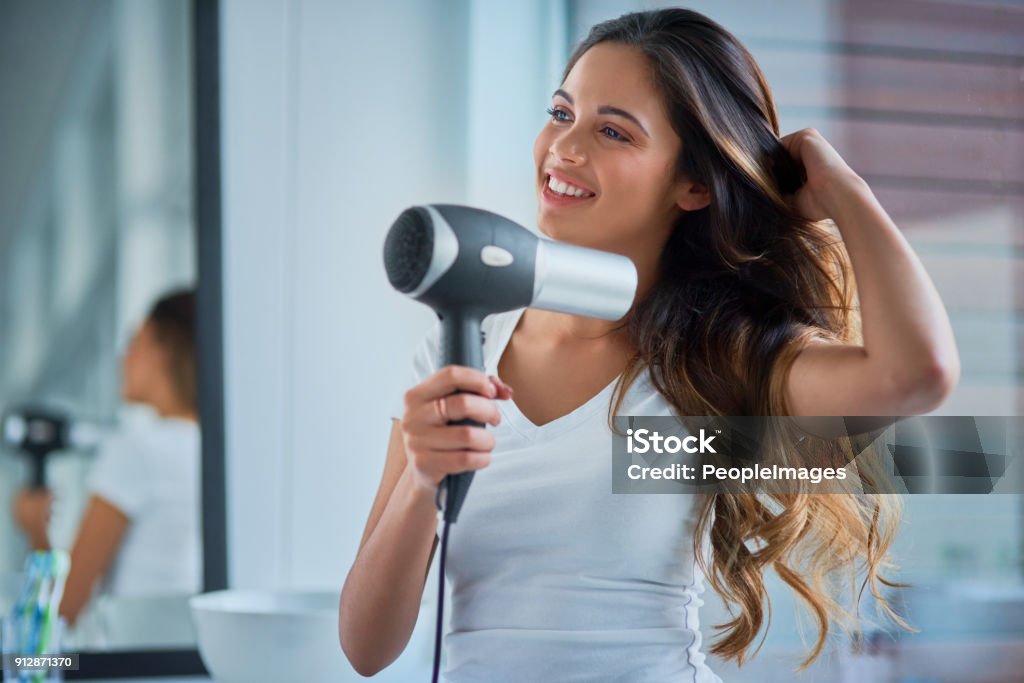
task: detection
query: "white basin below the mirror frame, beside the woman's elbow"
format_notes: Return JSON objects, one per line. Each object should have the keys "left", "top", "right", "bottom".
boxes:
{"left": 189, "top": 590, "right": 354, "bottom": 683}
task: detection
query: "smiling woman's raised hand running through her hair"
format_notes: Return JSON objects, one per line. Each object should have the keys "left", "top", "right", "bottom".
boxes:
{"left": 780, "top": 128, "right": 863, "bottom": 220}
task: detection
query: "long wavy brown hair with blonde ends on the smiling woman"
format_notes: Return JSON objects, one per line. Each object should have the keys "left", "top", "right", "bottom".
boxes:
{"left": 562, "top": 9, "right": 911, "bottom": 670}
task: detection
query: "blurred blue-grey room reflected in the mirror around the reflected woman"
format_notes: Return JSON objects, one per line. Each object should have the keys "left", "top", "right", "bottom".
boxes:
{"left": 0, "top": 0, "right": 196, "bottom": 649}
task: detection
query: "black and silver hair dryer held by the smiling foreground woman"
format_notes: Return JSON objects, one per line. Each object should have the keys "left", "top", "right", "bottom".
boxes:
{"left": 384, "top": 204, "right": 637, "bottom": 522}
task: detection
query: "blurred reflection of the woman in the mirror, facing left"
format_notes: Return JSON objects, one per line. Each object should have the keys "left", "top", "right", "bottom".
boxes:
{"left": 14, "top": 291, "right": 202, "bottom": 626}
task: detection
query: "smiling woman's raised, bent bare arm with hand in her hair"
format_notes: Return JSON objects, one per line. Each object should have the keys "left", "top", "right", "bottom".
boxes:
{"left": 786, "top": 131, "right": 959, "bottom": 416}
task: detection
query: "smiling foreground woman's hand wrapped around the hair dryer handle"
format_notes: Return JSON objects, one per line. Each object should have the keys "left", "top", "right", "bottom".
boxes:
{"left": 401, "top": 366, "right": 512, "bottom": 492}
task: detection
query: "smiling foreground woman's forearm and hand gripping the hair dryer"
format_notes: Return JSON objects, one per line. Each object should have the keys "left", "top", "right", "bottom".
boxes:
{"left": 338, "top": 366, "right": 511, "bottom": 676}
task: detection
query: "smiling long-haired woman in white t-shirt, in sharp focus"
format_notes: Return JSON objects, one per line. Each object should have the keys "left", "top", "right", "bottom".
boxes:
{"left": 339, "top": 9, "right": 959, "bottom": 683}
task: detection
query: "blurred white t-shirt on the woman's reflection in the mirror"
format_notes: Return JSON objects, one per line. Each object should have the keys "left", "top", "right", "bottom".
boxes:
{"left": 88, "top": 419, "right": 203, "bottom": 597}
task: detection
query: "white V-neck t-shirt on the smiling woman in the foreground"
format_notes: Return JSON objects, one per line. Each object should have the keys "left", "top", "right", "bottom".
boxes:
{"left": 394, "top": 308, "right": 721, "bottom": 683}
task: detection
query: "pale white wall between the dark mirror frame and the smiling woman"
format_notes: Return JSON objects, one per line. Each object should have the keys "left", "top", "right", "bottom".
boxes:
{"left": 221, "top": 0, "right": 564, "bottom": 671}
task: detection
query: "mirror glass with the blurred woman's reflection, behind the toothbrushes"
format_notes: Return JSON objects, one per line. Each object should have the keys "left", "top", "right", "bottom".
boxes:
{"left": 0, "top": 0, "right": 203, "bottom": 652}
